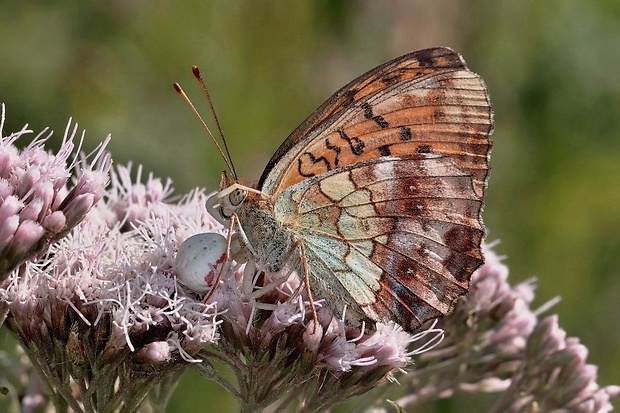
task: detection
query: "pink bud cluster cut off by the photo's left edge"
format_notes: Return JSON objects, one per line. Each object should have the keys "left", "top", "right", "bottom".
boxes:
{"left": 0, "top": 105, "right": 111, "bottom": 281}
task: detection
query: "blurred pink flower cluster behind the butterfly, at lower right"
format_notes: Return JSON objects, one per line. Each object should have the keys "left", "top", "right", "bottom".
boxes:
{"left": 382, "top": 245, "right": 620, "bottom": 413}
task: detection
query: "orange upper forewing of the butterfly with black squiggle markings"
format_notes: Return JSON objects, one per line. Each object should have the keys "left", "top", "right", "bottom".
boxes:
{"left": 258, "top": 48, "right": 493, "bottom": 196}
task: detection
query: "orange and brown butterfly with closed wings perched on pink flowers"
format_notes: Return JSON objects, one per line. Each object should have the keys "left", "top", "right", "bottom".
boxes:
{"left": 208, "top": 47, "right": 493, "bottom": 331}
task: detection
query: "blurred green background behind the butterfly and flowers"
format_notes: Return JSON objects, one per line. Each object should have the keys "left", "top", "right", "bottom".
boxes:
{"left": 0, "top": 0, "right": 620, "bottom": 412}
